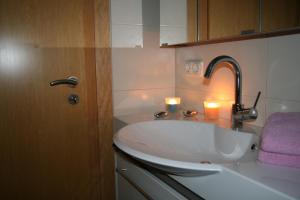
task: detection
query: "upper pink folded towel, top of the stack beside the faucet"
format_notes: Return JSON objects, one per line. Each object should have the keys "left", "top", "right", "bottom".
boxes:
{"left": 261, "top": 112, "right": 300, "bottom": 155}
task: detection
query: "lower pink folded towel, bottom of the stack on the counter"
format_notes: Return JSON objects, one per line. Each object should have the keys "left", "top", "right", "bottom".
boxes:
{"left": 258, "top": 150, "right": 300, "bottom": 168}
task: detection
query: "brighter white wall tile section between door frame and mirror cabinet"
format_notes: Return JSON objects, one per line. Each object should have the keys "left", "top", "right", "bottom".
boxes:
{"left": 112, "top": 25, "right": 143, "bottom": 48}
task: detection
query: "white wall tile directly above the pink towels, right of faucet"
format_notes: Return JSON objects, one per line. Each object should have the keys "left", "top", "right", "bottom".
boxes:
{"left": 268, "top": 34, "right": 300, "bottom": 101}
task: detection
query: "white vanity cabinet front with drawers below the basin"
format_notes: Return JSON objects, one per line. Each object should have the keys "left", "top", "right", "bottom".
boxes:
{"left": 115, "top": 153, "right": 187, "bottom": 200}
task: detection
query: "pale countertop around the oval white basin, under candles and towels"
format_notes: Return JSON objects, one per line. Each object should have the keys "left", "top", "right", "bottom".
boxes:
{"left": 114, "top": 112, "right": 300, "bottom": 200}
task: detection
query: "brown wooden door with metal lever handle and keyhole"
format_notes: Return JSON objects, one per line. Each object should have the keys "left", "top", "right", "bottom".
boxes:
{"left": 0, "top": 0, "right": 110, "bottom": 200}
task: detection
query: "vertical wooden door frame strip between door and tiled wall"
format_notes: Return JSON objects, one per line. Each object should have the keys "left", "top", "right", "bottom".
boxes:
{"left": 95, "top": 0, "right": 115, "bottom": 200}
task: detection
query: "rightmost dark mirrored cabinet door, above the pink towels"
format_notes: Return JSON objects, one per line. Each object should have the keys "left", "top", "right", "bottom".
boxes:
{"left": 262, "top": 0, "right": 300, "bottom": 32}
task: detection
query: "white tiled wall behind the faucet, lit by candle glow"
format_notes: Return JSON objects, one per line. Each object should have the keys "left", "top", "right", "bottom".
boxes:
{"left": 175, "top": 34, "right": 300, "bottom": 126}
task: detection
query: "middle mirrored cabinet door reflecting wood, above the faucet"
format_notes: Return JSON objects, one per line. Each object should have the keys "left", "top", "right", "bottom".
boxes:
{"left": 208, "top": 0, "right": 259, "bottom": 39}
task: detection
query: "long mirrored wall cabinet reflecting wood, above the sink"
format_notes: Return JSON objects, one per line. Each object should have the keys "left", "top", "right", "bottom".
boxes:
{"left": 160, "top": 0, "right": 300, "bottom": 46}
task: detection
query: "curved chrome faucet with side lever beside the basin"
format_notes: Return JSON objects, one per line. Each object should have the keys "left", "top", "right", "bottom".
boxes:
{"left": 204, "top": 55, "right": 261, "bottom": 129}
